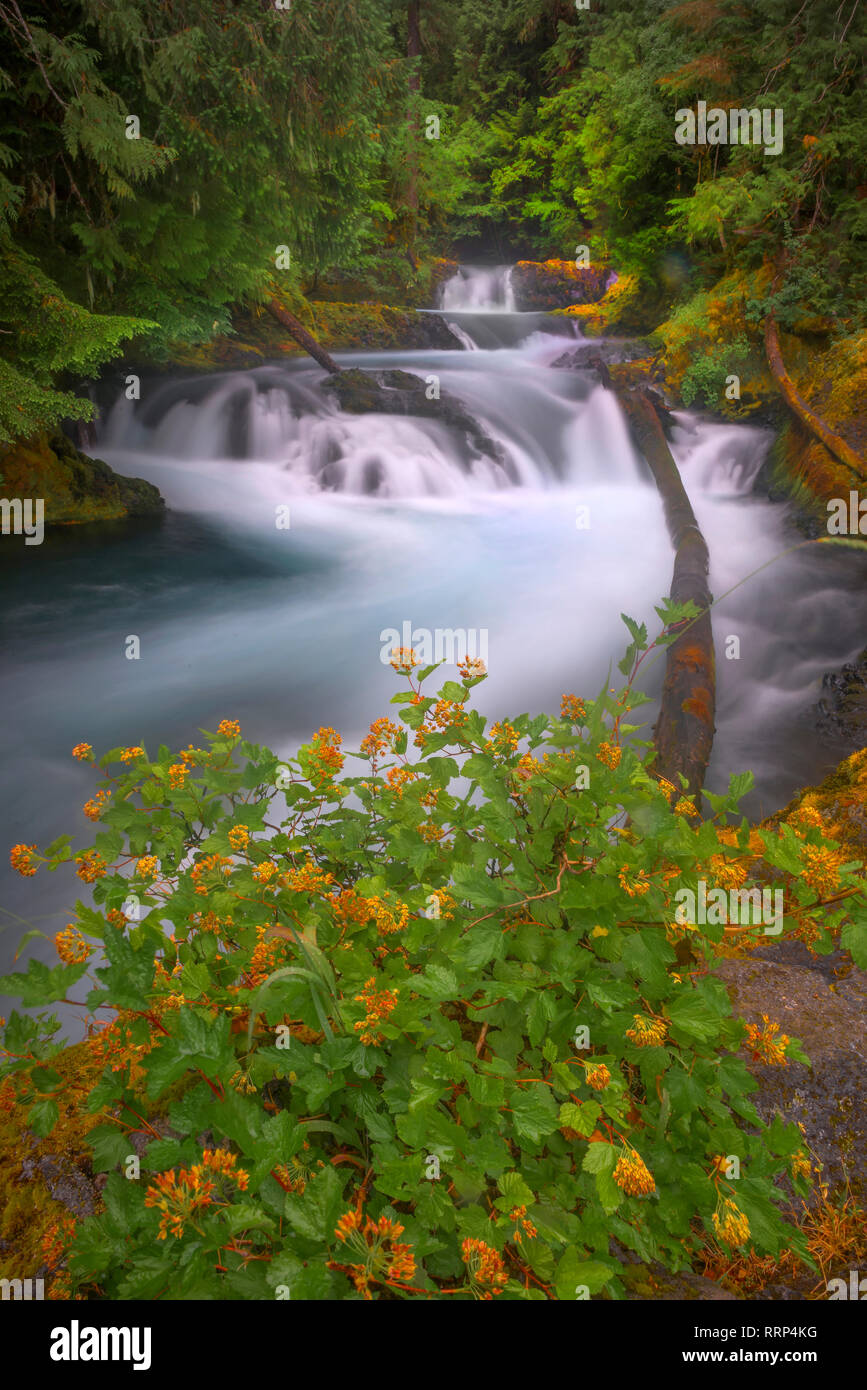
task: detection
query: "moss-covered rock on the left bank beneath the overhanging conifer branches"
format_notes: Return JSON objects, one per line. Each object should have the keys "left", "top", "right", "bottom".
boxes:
{"left": 0, "top": 434, "right": 165, "bottom": 525}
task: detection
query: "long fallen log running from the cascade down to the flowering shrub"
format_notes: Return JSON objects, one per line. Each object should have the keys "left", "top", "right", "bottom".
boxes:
{"left": 606, "top": 373, "right": 716, "bottom": 798}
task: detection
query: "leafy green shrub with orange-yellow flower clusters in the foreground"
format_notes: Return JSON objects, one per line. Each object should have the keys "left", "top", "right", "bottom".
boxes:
{"left": 0, "top": 606, "right": 867, "bottom": 1300}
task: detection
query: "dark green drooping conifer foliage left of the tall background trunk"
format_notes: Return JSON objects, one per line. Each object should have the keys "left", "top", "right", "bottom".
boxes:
{"left": 0, "top": 0, "right": 392, "bottom": 434}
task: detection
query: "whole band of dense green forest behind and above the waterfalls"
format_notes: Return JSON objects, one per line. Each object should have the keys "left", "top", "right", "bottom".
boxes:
{"left": 0, "top": 0, "right": 867, "bottom": 441}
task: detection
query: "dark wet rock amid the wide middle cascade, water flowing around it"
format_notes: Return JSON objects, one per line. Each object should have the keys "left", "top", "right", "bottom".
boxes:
{"left": 322, "top": 367, "right": 511, "bottom": 474}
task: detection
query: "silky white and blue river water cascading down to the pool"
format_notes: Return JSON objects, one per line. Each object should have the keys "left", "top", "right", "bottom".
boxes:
{"left": 0, "top": 268, "right": 867, "bottom": 1034}
